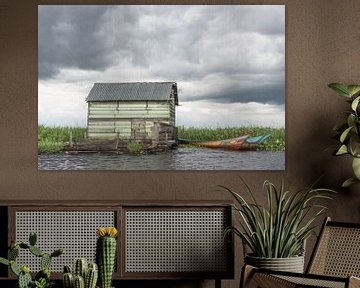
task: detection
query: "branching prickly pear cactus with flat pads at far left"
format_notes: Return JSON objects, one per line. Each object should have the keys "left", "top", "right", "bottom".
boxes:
{"left": 0, "top": 233, "right": 64, "bottom": 288}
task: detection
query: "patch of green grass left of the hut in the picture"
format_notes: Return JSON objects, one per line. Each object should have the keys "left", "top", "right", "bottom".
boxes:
{"left": 38, "top": 125, "right": 86, "bottom": 154}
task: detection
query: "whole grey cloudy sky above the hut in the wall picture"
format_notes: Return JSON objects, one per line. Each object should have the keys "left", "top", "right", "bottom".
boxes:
{"left": 38, "top": 5, "right": 285, "bottom": 127}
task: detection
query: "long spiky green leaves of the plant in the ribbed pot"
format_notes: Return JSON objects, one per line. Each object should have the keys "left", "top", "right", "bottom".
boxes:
{"left": 220, "top": 179, "right": 334, "bottom": 258}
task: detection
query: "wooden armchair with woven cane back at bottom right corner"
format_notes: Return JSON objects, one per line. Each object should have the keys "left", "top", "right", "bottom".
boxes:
{"left": 240, "top": 218, "right": 360, "bottom": 288}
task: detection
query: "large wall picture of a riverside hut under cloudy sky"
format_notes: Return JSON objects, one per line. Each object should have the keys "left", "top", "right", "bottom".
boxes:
{"left": 38, "top": 5, "right": 285, "bottom": 171}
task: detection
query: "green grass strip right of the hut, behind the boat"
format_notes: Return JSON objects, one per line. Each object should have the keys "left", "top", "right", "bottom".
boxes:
{"left": 178, "top": 126, "right": 285, "bottom": 151}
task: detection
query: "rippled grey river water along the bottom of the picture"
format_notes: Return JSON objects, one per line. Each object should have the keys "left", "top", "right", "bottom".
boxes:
{"left": 38, "top": 148, "right": 285, "bottom": 170}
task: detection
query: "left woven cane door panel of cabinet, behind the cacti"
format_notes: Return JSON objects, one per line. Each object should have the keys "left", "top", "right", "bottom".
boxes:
{"left": 16, "top": 211, "right": 115, "bottom": 272}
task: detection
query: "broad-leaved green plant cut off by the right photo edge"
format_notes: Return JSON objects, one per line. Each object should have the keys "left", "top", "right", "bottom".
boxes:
{"left": 328, "top": 83, "right": 360, "bottom": 187}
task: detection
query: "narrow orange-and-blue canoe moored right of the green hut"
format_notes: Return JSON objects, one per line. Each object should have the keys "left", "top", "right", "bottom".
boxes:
{"left": 178, "top": 134, "right": 270, "bottom": 150}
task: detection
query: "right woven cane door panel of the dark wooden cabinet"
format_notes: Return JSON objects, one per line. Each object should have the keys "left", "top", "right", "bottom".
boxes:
{"left": 125, "top": 210, "right": 226, "bottom": 272}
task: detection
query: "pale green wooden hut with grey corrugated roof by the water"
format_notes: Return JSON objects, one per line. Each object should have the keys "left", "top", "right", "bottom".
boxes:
{"left": 82, "top": 82, "right": 179, "bottom": 152}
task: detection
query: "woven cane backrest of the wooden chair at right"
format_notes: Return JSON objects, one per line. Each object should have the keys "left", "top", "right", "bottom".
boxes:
{"left": 307, "top": 218, "right": 360, "bottom": 277}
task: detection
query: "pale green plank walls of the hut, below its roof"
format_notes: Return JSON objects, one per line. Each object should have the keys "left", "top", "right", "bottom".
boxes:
{"left": 87, "top": 99, "right": 175, "bottom": 140}
